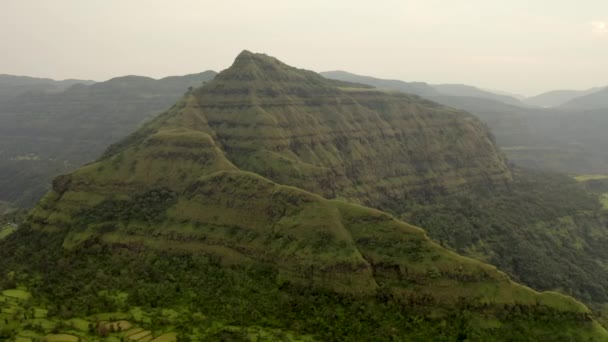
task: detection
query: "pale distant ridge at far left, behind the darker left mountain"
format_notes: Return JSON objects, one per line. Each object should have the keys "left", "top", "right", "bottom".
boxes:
{"left": 0, "top": 74, "right": 95, "bottom": 102}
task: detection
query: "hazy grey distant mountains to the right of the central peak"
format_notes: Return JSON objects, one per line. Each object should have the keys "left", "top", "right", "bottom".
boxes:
{"left": 325, "top": 73, "right": 608, "bottom": 174}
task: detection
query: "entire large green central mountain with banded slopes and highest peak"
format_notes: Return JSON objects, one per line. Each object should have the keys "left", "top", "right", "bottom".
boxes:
{"left": 0, "top": 51, "right": 608, "bottom": 341}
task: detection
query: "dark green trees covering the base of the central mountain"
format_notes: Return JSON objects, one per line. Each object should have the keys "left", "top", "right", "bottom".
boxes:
{"left": 0, "top": 224, "right": 604, "bottom": 341}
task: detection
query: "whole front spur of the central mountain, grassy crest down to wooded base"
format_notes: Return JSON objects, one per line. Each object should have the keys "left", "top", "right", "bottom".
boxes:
{"left": 0, "top": 50, "right": 606, "bottom": 340}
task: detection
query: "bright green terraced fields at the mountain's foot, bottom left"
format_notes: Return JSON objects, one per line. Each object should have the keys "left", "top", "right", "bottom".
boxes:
{"left": 0, "top": 287, "right": 315, "bottom": 342}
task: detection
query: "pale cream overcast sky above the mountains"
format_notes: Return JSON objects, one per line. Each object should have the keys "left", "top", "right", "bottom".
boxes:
{"left": 0, "top": 0, "right": 608, "bottom": 95}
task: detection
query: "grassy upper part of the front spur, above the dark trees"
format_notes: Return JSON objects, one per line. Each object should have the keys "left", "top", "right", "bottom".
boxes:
{"left": 0, "top": 62, "right": 604, "bottom": 337}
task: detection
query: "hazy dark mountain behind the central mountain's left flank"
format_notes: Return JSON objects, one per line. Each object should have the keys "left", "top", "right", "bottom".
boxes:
{"left": 0, "top": 71, "right": 215, "bottom": 207}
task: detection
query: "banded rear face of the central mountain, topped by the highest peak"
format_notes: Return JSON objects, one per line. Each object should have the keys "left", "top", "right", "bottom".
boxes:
{"left": 182, "top": 52, "right": 510, "bottom": 204}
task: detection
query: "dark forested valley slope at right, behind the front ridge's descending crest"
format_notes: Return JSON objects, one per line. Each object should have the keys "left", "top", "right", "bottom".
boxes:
{"left": 403, "top": 170, "right": 608, "bottom": 303}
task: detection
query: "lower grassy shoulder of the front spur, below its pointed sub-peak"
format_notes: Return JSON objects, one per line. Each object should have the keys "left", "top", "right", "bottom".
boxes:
{"left": 8, "top": 171, "right": 606, "bottom": 340}
